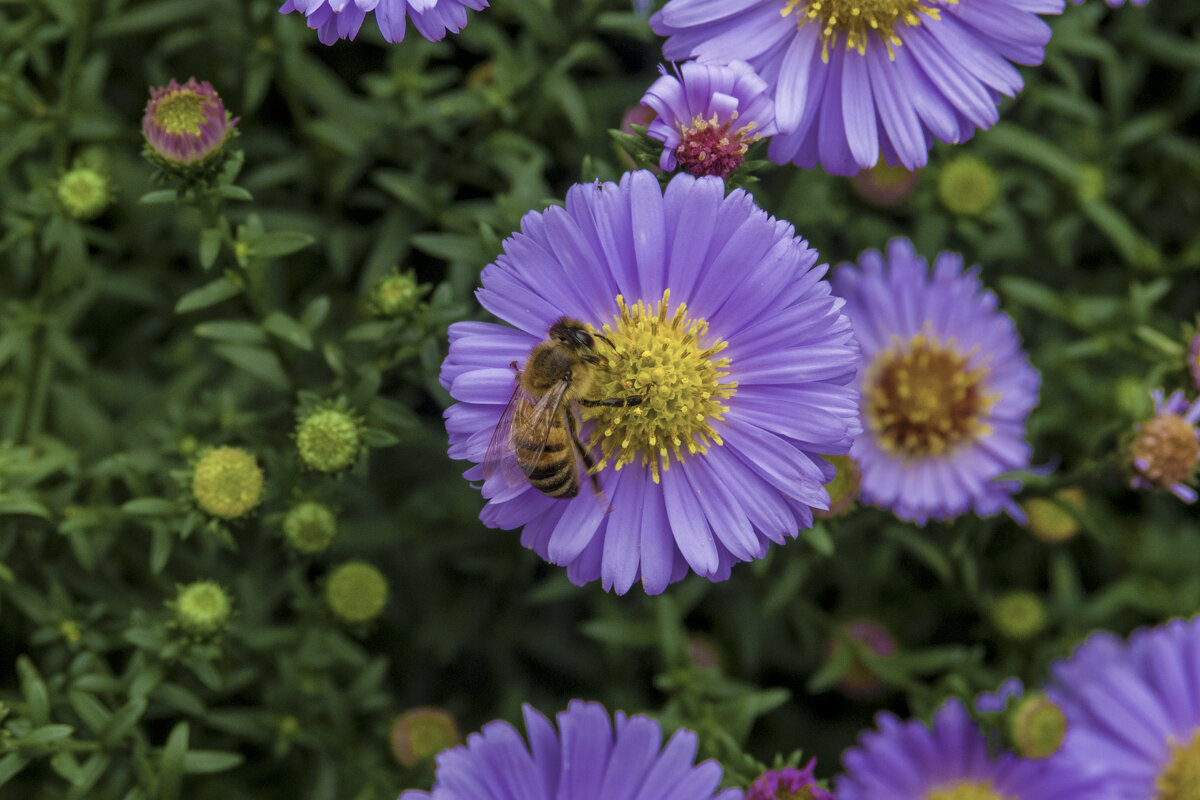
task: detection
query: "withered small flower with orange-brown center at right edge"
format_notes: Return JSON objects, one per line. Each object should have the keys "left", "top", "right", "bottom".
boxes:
{"left": 1129, "top": 389, "right": 1200, "bottom": 503}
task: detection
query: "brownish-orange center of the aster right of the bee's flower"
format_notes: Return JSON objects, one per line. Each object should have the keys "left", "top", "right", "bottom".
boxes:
{"left": 863, "top": 331, "right": 998, "bottom": 459}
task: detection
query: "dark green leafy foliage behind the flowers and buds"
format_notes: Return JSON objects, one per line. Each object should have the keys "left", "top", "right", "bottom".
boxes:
{"left": 0, "top": 0, "right": 1200, "bottom": 800}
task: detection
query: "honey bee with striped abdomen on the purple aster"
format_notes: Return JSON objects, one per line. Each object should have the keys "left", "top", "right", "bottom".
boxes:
{"left": 484, "top": 317, "right": 644, "bottom": 498}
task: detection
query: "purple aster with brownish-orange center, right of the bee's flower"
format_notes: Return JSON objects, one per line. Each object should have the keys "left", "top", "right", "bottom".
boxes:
{"left": 833, "top": 239, "right": 1039, "bottom": 524}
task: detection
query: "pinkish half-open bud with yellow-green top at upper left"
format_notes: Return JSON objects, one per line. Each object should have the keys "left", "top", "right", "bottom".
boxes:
{"left": 142, "top": 78, "right": 238, "bottom": 176}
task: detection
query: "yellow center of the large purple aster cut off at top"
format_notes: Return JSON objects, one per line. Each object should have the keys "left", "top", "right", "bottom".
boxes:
{"left": 780, "top": 0, "right": 958, "bottom": 62}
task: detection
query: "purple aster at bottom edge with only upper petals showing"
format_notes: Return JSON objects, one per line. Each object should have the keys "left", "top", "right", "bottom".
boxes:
{"left": 400, "top": 700, "right": 743, "bottom": 800}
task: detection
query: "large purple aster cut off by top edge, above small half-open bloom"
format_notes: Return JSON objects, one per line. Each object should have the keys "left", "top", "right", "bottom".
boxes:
{"left": 650, "top": 0, "right": 1063, "bottom": 175}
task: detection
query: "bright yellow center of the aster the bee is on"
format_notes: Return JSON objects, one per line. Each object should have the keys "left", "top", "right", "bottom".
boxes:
{"left": 583, "top": 290, "right": 737, "bottom": 483}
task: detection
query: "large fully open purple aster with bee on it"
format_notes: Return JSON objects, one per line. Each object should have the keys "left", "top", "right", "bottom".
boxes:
{"left": 440, "top": 170, "right": 858, "bottom": 594}
